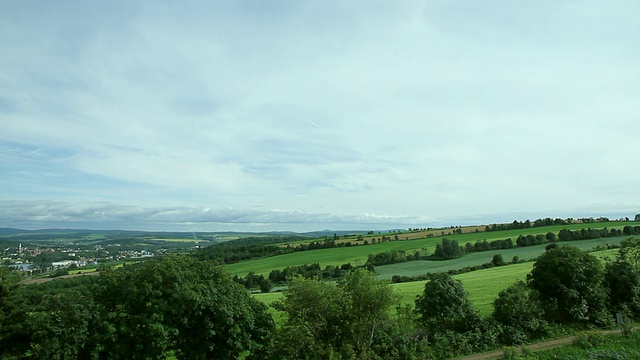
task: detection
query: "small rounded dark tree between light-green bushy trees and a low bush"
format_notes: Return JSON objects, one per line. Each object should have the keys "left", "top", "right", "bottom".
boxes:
{"left": 415, "top": 273, "right": 479, "bottom": 333}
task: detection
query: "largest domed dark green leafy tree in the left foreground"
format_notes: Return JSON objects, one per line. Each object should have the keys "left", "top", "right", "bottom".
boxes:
{"left": 95, "top": 256, "right": 274, "bottom": 359}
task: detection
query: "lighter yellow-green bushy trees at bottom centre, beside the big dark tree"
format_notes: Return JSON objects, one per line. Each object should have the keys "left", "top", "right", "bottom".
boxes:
{"left": 271, "top": 269, "right": 397, "bottom": 358}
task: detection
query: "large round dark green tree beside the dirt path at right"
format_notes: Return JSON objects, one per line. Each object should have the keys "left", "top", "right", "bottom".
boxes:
{"left": 527, "top": 246, "right": 606, "bottom": 323}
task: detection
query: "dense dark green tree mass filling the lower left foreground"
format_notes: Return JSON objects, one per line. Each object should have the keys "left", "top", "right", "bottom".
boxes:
{"left": 0, "top": 256, "right": 274, "bottom": 359}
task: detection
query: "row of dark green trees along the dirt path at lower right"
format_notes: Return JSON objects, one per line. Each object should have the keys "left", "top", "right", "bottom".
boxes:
{"left": 415, "top": 242, "right": 640, "bottom": 356}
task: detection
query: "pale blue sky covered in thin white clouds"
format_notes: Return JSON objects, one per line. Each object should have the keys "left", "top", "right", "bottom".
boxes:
{"left": 0, "top": 0, "right": 640, "bottom": 231}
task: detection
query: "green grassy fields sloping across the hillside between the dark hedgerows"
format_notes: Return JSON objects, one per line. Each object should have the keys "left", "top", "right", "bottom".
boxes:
{"left": 246, "top": 222, "right": 640, "bottom": 319}
